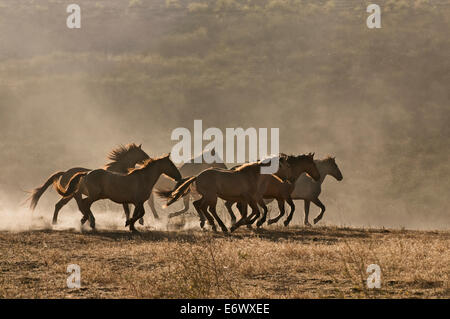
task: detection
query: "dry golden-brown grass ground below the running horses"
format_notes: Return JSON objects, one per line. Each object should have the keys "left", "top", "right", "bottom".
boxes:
{"left": 0, "top": 227, "right": 450, "bottom": 298}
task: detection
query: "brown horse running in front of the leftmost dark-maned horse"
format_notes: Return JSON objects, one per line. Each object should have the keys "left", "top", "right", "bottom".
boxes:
{"left": 59, "top": 153, "right": 181, "bottom": 232}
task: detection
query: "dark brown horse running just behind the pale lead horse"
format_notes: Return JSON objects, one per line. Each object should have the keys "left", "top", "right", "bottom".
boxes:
{"left": 225, "top": 153, "right": 321, "bottom": 227}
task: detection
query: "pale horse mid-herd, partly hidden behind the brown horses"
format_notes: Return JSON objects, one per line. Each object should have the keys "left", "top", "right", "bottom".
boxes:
{"left": 148, "top": 148, "right": 227, "bottom": 218}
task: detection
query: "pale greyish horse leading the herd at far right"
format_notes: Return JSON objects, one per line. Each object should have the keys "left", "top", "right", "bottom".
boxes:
{"left": 268, "top": 156, "right": 343, "bottom": 227}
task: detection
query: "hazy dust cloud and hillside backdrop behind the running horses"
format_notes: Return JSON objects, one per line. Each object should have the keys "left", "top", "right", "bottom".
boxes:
{"left": 0, "top": 0, "right": 450, "bottom": 231}
